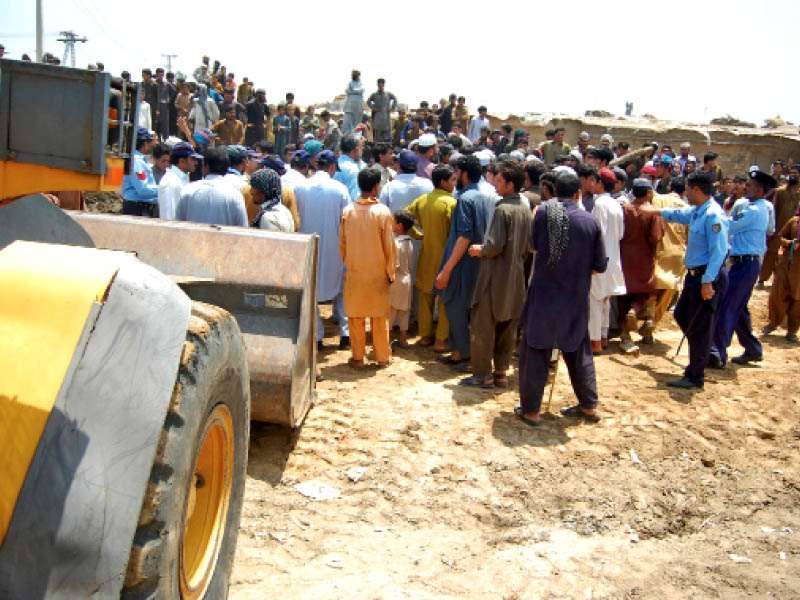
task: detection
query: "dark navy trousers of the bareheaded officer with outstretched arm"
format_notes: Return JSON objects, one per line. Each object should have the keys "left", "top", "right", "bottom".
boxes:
{"left": 674, "top": 265, "right": 728, "bottom": 385}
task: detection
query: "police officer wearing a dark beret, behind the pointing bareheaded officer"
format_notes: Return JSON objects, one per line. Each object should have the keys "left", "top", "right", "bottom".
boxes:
{"left": 709, "top": 171, "right": 777, "bottom": 369}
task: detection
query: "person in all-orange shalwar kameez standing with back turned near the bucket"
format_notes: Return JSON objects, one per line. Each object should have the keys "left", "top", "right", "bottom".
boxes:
{"left": 339, "top": 168, "right": 397, "bottom": 368}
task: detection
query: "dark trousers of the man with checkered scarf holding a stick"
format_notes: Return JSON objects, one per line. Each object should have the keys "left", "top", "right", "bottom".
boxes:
{"left": 519, "top": 328, "right": 597, "bottom": 413}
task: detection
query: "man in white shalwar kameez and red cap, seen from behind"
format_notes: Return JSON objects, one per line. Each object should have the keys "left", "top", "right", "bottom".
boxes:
{"left": 589, "top": 168, "right": 625, "bottom": 354}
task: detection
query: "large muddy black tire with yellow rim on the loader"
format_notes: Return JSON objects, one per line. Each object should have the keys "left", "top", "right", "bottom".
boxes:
{"left": 120, "top": 302, "right": 250, "bottom": 600}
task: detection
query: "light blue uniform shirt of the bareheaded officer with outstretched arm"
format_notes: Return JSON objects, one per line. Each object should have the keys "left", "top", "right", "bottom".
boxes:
{"left": 661, "top": 197, "right": 728, "bottom": 283}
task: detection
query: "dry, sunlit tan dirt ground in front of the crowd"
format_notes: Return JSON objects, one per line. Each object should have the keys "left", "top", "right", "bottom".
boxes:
{"left": 230, "top": 291, "right": 800, "bottom": 600}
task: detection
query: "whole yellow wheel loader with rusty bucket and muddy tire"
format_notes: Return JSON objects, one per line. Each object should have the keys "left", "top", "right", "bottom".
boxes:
{"left": 0, "top": 59, "right": 318, "bottom": 600}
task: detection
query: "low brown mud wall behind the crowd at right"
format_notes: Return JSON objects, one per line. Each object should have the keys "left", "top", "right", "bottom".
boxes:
{"left": 492, "top": 115, "right": 800, "bottom": 176}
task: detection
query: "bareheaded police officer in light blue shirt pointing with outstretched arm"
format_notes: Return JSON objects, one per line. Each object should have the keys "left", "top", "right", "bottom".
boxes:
{"left": 647, "top": 171, "right": 728, "bottom": 389}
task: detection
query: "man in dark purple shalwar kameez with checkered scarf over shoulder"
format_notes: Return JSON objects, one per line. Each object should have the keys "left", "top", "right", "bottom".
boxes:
{"left": 514, "top": 168, "right": 608, "bottom": 425}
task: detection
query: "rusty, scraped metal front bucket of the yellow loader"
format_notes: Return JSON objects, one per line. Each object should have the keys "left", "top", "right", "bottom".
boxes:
{"left": 65, "top": 211, "right": 319, "bottom": 427}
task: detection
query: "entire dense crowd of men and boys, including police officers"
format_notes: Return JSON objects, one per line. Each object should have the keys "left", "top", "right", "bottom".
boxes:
{"left": 84, "top": 57, "right": 800, "bottom": 426}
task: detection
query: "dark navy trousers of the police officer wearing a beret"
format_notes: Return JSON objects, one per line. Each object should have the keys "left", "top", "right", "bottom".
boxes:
{"left": 711, "top": 260, "right": 762, "bottom": 363}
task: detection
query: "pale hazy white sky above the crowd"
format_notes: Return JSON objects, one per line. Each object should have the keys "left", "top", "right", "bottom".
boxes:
{"left": 0, "top": 0, "right": 800, "bottom": 125}
